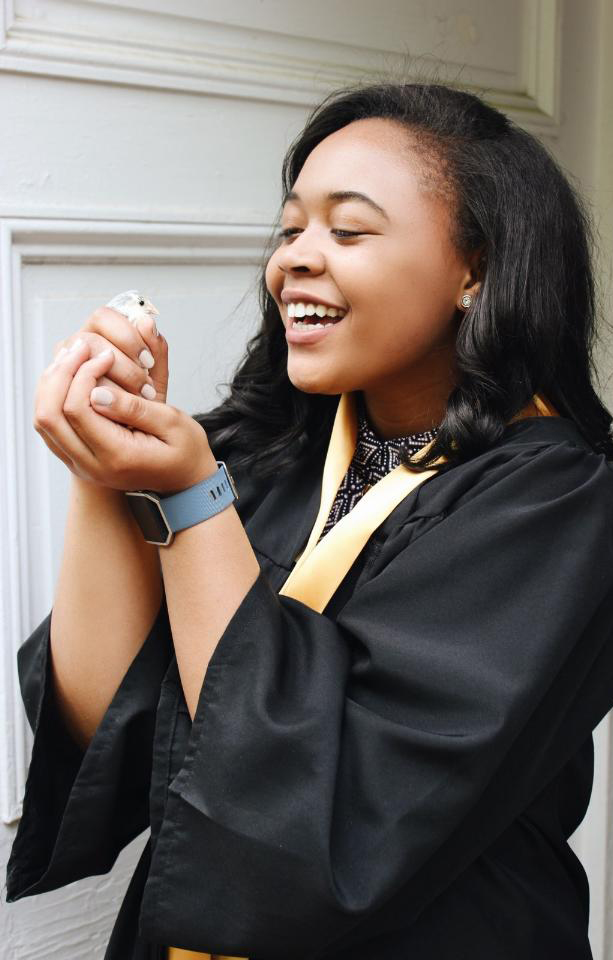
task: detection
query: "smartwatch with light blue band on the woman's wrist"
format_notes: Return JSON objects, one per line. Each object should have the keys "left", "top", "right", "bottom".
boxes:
{"left": 125, "top": 460, "right": 238, "bottom": 547}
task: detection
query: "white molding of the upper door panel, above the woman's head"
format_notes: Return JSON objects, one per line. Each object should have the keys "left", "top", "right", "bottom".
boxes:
{"left": 0, "top": 0, "right": 562, "bottom": 136}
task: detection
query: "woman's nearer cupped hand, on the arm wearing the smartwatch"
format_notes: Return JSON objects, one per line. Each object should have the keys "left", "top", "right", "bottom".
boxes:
{"left": 34, "top": 341, "right": 217, "bottom": 493}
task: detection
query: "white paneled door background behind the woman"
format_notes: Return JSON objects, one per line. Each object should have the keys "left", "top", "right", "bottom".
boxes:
{"left": 0, "top": 0, "right": 613, "bottom": 960}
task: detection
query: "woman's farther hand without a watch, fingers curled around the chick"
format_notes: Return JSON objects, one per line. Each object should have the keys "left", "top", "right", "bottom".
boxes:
{"left": 34, "top": 307, "right": 168, "bottom": 482}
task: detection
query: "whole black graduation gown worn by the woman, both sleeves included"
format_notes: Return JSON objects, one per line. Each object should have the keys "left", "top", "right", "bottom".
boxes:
{"left": 7, "top": 417, "right": 613, "bottom": 960}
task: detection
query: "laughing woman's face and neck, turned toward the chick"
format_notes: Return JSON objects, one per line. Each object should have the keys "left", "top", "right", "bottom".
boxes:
{"left": 266, "top": 118, "right": 478, "bottom": 437}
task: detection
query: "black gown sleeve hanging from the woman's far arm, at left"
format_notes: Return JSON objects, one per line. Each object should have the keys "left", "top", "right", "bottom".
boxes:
{"left": 6, "top": 598, "right": 172, "bottom": 903}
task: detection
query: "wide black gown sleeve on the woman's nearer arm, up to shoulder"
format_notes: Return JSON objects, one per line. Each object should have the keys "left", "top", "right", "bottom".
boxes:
{"left": 140, "top": 442, "right": 613, "bottom": 960}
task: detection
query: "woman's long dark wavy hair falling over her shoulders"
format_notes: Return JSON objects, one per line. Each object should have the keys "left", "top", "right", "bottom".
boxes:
{"left": 195, "top": 82, "right": 613, "bottom": 477}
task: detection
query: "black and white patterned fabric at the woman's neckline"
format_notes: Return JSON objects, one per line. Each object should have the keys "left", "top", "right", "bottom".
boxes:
{"left": 318, "top": 391, "right": 438, "bottom": 542}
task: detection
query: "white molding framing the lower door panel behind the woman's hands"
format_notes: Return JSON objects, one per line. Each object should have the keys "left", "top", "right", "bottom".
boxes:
{"left": 0, "top": 217, "right": 271, "bottom": 823}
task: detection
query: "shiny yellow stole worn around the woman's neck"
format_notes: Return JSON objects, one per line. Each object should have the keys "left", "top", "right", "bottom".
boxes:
{"left": 167, "top": 393, "right": 559, "bottom": 960}
